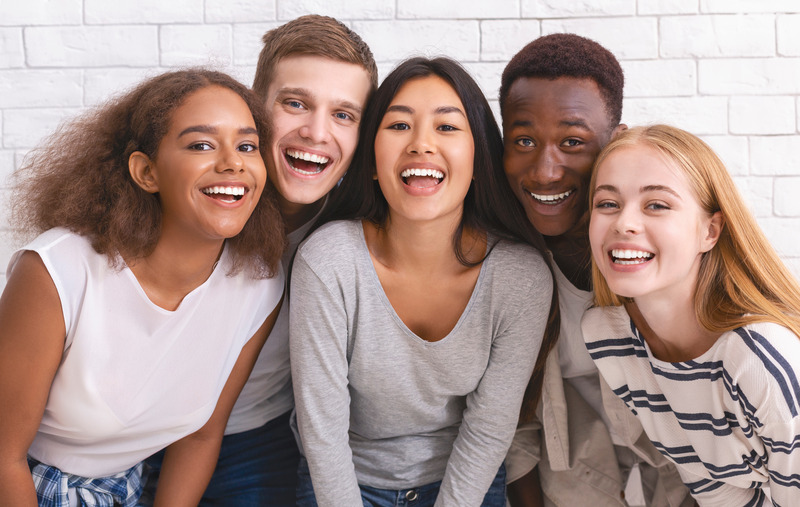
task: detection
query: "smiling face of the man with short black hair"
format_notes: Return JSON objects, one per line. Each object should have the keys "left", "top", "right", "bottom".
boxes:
{"left": 503, "top": 77, "right": 624, "bottom": 236}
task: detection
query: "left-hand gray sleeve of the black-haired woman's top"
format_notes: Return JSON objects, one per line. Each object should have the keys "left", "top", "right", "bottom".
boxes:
{"left": 289, "top": 250, "right": 362, "bottom": 507}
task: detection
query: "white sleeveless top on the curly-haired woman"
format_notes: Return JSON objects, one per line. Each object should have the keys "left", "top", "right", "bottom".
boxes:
{"left": 8, "top": 228, "right": 284, "bottom": 477}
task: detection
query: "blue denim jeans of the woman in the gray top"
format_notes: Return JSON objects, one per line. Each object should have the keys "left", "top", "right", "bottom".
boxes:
{"left": 297, "top": 457, "right": 506, "bottom": 507}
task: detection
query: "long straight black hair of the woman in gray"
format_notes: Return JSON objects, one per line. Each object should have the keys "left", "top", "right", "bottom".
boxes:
{"left": 316, "top": 57, "right": 559, "bottom": 416}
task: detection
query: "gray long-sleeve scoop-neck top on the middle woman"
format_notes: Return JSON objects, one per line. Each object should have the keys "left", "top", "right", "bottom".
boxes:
{"left": 290, "top": 221, "right": 552, "bottom": 507}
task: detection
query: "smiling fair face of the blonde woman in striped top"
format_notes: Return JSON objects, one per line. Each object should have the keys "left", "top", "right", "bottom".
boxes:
{"left": 589, "top": 144, "right": 722, "bottom": 303}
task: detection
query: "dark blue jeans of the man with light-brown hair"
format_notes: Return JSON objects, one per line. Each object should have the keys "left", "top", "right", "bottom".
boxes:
{"left": 143, "top": 412, "right": 300, "bottom": 507}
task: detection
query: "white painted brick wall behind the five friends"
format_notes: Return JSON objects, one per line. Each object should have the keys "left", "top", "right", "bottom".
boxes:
{"left": 0, "top": 0, "right": 800, "bottom": 292}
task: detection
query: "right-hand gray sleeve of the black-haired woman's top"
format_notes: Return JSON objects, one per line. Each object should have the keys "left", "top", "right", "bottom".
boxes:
{"left": 436, "top": 257, "right": 553, "bottom": 507}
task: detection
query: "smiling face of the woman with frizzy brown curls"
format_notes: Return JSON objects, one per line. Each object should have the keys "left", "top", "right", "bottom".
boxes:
{"left": 136, "top": 86, "right": 267, "bottom": 241}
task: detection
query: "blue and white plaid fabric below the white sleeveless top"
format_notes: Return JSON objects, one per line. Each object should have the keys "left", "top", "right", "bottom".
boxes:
{"left": 28, "top": 456, "right": 142, "bottom": 507}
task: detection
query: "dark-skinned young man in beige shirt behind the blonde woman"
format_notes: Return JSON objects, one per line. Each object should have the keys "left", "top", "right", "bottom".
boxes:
{"left": 500, "top": 34, "right": 693, "bottom": 507}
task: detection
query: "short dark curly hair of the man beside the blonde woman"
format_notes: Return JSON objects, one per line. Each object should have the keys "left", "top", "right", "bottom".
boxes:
{"left": 500, "top": 33, "right": 625, "bottom": 129}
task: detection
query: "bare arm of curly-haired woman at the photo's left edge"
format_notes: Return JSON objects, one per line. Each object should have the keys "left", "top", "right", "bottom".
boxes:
{"left": 0, "top": 251, "right": 66, "bottom": 506}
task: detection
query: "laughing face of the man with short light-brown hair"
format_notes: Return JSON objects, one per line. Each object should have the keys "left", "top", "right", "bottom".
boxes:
{"left": 266, "top": 55, "right": 370, "bottom": 213}
